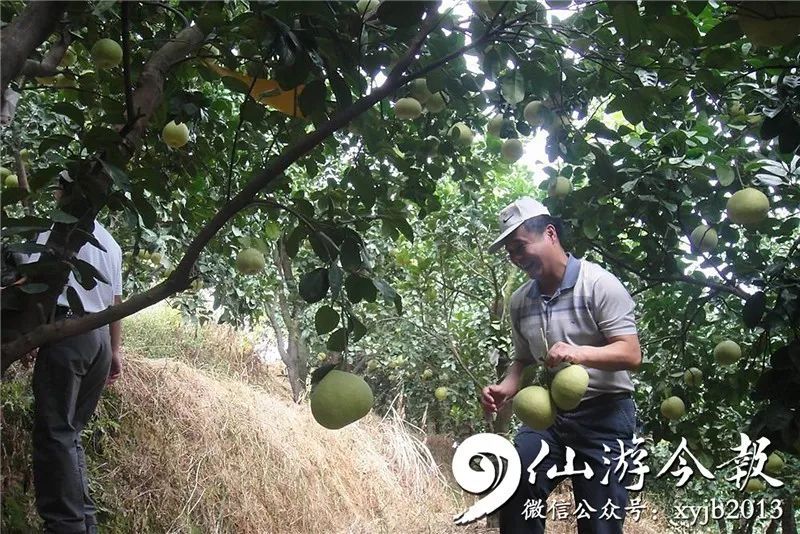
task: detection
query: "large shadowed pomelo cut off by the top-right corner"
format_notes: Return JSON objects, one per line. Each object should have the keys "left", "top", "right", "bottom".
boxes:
{"left": 736, "top": 2, "right": 800, "bottom": 47}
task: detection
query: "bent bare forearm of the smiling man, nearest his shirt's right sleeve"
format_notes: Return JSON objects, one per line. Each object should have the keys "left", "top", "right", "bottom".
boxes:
{"left": 546, "top": 334, "right": 642, "bottom": 371}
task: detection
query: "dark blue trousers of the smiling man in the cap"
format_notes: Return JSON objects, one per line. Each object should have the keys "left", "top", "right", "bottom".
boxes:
{"left": 499, "top": 398, "right": 636, "bottom": 534}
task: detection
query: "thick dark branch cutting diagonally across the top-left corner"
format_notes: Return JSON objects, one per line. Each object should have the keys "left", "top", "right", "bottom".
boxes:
{"left": 0, "top": 2, "right": 67, "bottom": 94}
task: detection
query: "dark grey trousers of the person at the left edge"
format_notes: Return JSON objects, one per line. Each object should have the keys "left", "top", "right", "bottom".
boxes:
{"left": 33, "top": 326, "right": 111, "bottom": 534}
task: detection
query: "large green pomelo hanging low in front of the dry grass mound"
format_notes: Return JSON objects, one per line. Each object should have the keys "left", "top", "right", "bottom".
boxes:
{"left": 311, "top": 369, "right": 374, "bottom": 430}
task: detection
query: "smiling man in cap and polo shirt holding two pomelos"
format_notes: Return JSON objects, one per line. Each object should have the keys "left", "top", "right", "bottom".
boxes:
{"left": 481, "top": 197, "right": 642, "bottom": 534}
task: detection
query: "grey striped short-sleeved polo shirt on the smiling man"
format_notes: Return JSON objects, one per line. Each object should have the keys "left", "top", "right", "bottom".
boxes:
{"left": 510, "top": 254, "right": 636, "bottom": 399}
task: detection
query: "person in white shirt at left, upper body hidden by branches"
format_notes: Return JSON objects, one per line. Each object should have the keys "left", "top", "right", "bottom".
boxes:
{"left": 19, "top": 177, "right": 122, "bottom": 534}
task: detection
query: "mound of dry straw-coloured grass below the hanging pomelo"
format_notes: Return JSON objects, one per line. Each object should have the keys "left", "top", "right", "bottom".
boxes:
{"left": 99, "top": 359, "right": 476, "bottom": 533}
